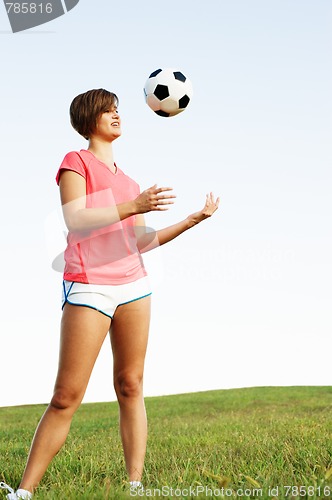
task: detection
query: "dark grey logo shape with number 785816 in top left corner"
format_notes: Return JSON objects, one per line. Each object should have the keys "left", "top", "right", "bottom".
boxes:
{"left": 3, "top": 0, "right": 79, "bottom": 33}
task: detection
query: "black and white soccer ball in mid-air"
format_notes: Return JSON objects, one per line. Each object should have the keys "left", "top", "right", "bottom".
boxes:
{"left": 144, "top": 68, "right": 193, "bottom": 117}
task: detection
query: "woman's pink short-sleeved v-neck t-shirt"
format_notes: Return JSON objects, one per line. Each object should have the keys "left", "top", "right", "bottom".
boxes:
{"left": 56, "top": 149, "right": 147, "bottom": 285}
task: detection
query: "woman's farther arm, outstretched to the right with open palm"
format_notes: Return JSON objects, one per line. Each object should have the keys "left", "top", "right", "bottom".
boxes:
{"left": 136, "top": 193, "right": 220, "bottom": 253}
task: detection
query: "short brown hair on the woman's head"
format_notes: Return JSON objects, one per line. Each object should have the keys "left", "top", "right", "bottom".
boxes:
{"left": 70, "top": 89, "right": 119, "bottom": 139}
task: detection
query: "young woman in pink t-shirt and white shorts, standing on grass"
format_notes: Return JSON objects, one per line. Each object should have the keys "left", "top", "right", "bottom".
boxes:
{"left": 1, "top": 89, "right": 219, "bottom": 500}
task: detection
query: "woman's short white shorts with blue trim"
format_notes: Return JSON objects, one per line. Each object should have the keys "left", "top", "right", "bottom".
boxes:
{"left": 62, "top": 276, "right": 152, "bottom": 318}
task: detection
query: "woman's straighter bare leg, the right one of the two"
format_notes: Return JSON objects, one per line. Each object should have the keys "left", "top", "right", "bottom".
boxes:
{"left": 111, "top": 297, "right": 151, "bottom": 481}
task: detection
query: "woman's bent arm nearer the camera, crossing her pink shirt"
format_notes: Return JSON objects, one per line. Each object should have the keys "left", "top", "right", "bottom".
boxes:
{"left": 59, "top": 170, "right": 175, "bottom": 232}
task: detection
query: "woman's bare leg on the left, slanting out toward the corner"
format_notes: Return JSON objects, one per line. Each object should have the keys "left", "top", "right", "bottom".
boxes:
{"left": 20, "top": 303, "right": 111, "bottom": 491}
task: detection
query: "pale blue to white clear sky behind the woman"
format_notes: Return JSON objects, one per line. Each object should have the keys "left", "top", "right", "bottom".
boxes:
{"left": 0, "top": 0, "right": 332, "bottom": 406}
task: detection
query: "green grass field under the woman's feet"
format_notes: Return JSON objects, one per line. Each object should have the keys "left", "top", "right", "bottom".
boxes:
{"left": 0, "top": 387, "right": 332, "bottom": 500}
